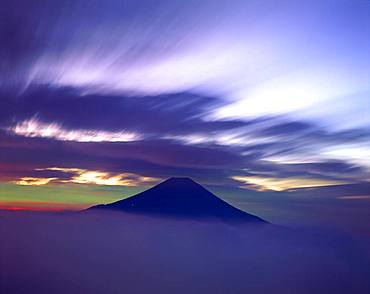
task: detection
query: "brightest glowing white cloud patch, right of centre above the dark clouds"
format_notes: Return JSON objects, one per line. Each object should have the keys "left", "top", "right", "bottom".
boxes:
{"left": 214, "top": 65, "right": 370, "bottom": 125}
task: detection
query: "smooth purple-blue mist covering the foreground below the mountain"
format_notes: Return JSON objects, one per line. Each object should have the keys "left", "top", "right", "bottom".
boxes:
{"left": 0, "top": 212, "right": 370, "bottom": 294}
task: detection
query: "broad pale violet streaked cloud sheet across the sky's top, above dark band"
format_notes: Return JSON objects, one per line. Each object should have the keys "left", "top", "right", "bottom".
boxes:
{"left": 0, "top": 0, "right": 370, "bottom": 127}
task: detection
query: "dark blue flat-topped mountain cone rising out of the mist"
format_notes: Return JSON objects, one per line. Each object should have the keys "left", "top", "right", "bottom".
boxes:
{"left": 88, "top": 178, "right": 266, "bottom": 223}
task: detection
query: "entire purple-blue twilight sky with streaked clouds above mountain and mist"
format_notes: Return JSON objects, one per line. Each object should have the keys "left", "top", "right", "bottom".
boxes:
{"left": 0, "top": 0, "right": 370, "bottom": 235}
